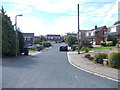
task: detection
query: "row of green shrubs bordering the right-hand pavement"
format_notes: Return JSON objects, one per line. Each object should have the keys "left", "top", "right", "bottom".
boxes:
{"left": 84, "top": 51, "right": 120, "bottom": 69}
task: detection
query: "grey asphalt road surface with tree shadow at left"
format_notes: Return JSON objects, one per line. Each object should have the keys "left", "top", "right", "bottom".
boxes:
{"left": 2, "top": 44, "right": 118, "bottom": 88}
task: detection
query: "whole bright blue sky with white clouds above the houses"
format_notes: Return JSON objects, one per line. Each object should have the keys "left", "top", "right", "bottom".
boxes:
{"left": 0, "top": 0, "right": 120, "bottom": 35}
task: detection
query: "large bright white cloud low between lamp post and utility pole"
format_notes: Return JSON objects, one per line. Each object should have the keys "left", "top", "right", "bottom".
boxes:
{"left": 12, "top": 16, "right": 77, "bottom": 35}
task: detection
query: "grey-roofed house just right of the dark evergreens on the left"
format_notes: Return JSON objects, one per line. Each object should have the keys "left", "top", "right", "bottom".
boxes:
{"left": 23, "top": 33, "right": 34, "bottom": 46}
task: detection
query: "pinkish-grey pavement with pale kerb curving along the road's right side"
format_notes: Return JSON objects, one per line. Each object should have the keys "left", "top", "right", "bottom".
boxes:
{"left": 67, "top": 50, "right": 120, "bottom": 82}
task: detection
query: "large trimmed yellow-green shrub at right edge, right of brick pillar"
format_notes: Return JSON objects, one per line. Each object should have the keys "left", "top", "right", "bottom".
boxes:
{"left": 108, "top": 51, "right": 120, "bottom": 68}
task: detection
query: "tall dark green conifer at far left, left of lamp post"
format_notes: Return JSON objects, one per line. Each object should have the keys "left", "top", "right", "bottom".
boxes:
{"left": 0, "top": 7, "right": 16, "bottom": 56}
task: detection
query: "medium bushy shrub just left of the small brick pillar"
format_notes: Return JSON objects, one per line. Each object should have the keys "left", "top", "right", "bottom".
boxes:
{"left": 93, "top": 53, "right": 108, "bottom": 64}
